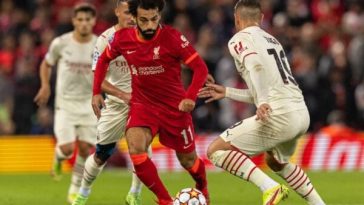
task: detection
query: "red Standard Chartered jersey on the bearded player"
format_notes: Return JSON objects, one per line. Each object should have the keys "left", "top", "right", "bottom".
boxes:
{"left": 105, "top": 25, "right": 207, "bottom": 109}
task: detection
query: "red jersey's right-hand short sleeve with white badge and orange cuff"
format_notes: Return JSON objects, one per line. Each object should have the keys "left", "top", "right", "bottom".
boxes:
{"left": 170, "top": 29, "right": 198, "bottom": 65}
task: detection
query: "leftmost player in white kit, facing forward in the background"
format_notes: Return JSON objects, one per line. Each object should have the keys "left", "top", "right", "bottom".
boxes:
{"left": 34, "top": 3, "right": 97, "bottom": 203}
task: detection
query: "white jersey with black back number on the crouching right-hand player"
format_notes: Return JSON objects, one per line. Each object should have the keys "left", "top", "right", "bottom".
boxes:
{"left": 228, "top": 26, "right": 306, "bottom": 114}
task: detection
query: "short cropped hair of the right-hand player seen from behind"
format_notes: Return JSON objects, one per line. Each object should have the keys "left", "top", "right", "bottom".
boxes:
{"left": 234, "top": 0, "right": 262, "bottom": 19}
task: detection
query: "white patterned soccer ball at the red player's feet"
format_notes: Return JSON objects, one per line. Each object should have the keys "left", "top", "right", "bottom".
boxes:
{"left": 173, "top": 188, "right": 207, "bottom": 205}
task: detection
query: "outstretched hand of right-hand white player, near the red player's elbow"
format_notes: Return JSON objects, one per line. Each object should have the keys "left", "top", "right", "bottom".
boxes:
{"left": 197, "top": 83, "right": 226, "bottom": 103}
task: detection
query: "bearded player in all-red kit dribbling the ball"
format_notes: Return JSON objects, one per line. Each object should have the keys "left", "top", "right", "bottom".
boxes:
{"left": 92, "top": 0, "right": 208, "bottom": 205}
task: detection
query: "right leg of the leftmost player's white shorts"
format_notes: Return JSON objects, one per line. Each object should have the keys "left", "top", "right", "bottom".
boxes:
{"left": 76, "top": 113, "right": 97, "bottom": 145}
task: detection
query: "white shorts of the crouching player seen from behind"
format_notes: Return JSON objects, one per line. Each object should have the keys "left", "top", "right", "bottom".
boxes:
{"left": 220, "top": 106, "right": 310, "bottom": 163}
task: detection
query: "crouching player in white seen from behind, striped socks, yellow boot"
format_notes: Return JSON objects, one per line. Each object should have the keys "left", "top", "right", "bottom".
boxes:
{"left": 199, "top": 0, "right": 324, "bottom": 205}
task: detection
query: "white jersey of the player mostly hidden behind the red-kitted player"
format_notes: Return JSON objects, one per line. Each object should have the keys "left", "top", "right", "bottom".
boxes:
{"left": 92, "top": 26, "right": 131, "bottom": 103}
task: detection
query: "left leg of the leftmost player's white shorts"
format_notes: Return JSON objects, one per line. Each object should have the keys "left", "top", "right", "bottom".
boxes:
{"left": 54, "top": 109, "right": 76, "bottom": 146}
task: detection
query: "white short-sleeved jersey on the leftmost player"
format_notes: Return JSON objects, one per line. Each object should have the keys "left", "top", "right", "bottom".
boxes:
{"left": 45, "top": 32, "right": 97, "bottom": 114}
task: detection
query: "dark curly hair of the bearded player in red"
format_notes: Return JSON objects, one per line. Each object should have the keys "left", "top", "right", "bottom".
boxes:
{"left": 128, "top": 0, "right": 166, "bottom": 17}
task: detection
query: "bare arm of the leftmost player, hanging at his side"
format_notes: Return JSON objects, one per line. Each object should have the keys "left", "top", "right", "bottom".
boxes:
{"left": 34, "top": 60, "right": 51, "bottom": 106}
